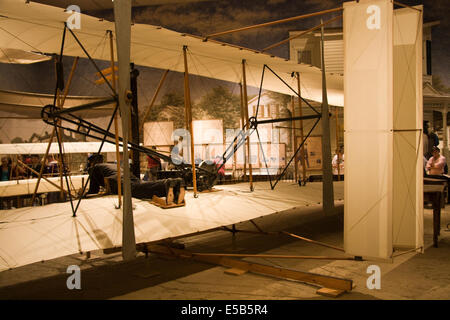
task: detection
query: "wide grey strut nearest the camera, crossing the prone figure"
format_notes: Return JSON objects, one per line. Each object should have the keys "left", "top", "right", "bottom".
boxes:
{"left": 114, "top": 0, "right": 136, "bottom": 261}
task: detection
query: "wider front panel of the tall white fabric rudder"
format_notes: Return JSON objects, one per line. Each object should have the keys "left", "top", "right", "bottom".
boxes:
{"left": 344, "top": 0, "right": 393, "bottom": 259}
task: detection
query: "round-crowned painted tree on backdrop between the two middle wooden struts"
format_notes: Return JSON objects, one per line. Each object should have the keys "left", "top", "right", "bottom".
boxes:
{"left": 195, "top": 86, "right": 241, "bottom": 129}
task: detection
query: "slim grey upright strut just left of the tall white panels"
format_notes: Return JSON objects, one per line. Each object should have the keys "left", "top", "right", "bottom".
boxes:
{"left": 321, "top": 21, "right": 334, "bottom": 214}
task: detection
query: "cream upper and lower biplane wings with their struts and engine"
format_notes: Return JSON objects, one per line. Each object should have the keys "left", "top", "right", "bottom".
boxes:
{"left": 0, "top": 0, "right": 362, "bottom": 290}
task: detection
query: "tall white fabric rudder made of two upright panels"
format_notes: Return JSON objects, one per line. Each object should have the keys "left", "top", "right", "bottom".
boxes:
{"left": 344, "top": 0, "right": 423, "bottom": 259}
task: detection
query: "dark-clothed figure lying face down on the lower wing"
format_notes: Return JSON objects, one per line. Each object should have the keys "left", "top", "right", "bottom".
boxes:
{"left": 87, "top": 154, "right": 185, "bottom": 204}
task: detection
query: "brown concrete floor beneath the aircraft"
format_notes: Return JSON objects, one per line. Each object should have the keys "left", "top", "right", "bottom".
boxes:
{"left": 0, "top": 182, "right": 450, "bottom": 300}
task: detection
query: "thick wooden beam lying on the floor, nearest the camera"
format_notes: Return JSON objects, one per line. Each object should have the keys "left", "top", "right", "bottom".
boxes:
{"left": 147, "top": 245, "right": 353, "bottom": 291}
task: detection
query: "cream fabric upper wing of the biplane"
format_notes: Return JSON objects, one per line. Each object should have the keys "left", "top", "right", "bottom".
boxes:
{"left": 0, "top": 0, "right": 344, "bottom": 106}
